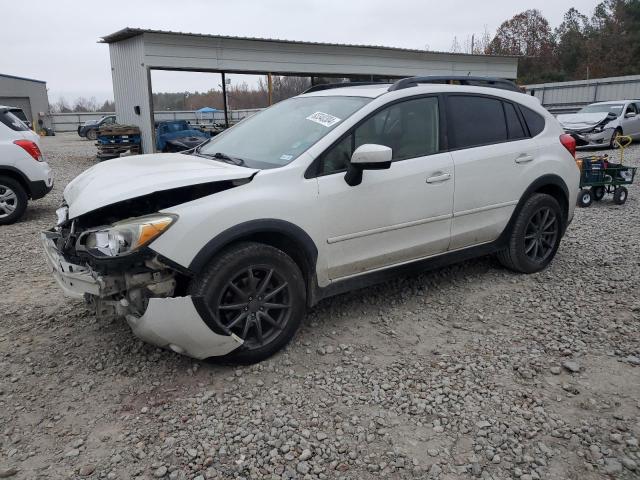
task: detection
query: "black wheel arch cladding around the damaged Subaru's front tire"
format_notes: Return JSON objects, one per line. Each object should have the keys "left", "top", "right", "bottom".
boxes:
{"left": 189, "top": 219, "right": 318, "bottom": 297}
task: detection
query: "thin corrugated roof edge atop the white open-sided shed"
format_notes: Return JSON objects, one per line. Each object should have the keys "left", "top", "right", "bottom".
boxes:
{"left": 99, "top": 27, "right": 518, "bottom": 58}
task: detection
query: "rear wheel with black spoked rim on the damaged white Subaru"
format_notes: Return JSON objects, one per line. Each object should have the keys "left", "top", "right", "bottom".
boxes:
{"left": 498, "top": 193, "right": 563, "bottom": 273}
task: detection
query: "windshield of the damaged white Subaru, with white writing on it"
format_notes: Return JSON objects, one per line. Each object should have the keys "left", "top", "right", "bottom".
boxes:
{"left": 199, "top": 96, "right": 371, "bottom": 168}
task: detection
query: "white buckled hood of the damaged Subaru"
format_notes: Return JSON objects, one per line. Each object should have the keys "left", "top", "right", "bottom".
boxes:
{"left": 64, "top": 153, "right": 258, "bottom": 218}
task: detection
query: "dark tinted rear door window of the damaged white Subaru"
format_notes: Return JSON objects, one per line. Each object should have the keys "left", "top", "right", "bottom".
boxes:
{"left": 447, "top": 95, "right": 508, "bottom": 149}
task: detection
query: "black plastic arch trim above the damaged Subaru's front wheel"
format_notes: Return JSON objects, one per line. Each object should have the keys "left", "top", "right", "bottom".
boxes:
{"left": 189, "top": 218, "right": 318, "bottom": 275}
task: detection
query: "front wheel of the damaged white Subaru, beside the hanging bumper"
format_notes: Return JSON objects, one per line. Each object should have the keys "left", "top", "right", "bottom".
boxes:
{"left": 189, "top": 242, "right": 306, "bottom": 364}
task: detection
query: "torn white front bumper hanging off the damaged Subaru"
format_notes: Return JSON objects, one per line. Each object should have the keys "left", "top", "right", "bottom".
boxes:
{"left": 41, "top": 231, "right": 242, "bottom": 359}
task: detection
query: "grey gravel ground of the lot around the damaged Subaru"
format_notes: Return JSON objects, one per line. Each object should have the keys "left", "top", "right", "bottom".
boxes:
{"left": 0, "top": 134, "right": 640, "bottom": 480}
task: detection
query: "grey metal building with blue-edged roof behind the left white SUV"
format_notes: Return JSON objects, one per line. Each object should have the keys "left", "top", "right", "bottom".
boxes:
{"left": 0, "top": 73, "right": 49, "bottom": 127}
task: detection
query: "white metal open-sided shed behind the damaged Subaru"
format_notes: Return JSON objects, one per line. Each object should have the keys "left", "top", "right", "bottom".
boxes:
{"left": 102, "top": 28, "right": 518, "bottom": 153}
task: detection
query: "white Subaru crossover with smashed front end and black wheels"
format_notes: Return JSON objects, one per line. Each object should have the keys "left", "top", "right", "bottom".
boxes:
{"left": 38, "top": 77, "right": 579, "bottom": 362}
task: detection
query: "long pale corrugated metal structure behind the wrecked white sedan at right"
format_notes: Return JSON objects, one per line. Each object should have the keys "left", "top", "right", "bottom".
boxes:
{"left": 525, "top": 75, "right": 640, "bottom": 113}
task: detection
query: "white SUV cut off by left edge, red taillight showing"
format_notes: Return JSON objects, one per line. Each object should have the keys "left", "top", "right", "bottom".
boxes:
{"left": 0, "top": 105, "right": 53, "bottom": 225}
